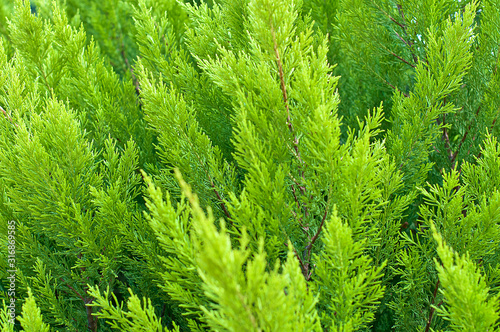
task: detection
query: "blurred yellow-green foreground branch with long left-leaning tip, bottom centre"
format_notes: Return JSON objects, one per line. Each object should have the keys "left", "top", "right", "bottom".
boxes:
{"left": 176, "top": 171, "right": 320, "bottom": 331}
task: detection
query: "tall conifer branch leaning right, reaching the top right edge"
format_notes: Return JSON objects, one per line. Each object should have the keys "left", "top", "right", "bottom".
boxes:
{"left": 387, "top": 0, "right": 476, "bottom": 192}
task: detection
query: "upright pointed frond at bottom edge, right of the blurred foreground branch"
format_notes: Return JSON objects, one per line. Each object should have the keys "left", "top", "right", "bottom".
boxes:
{"left": 316, "top": 210, "right": 384, "bottom": 331}
